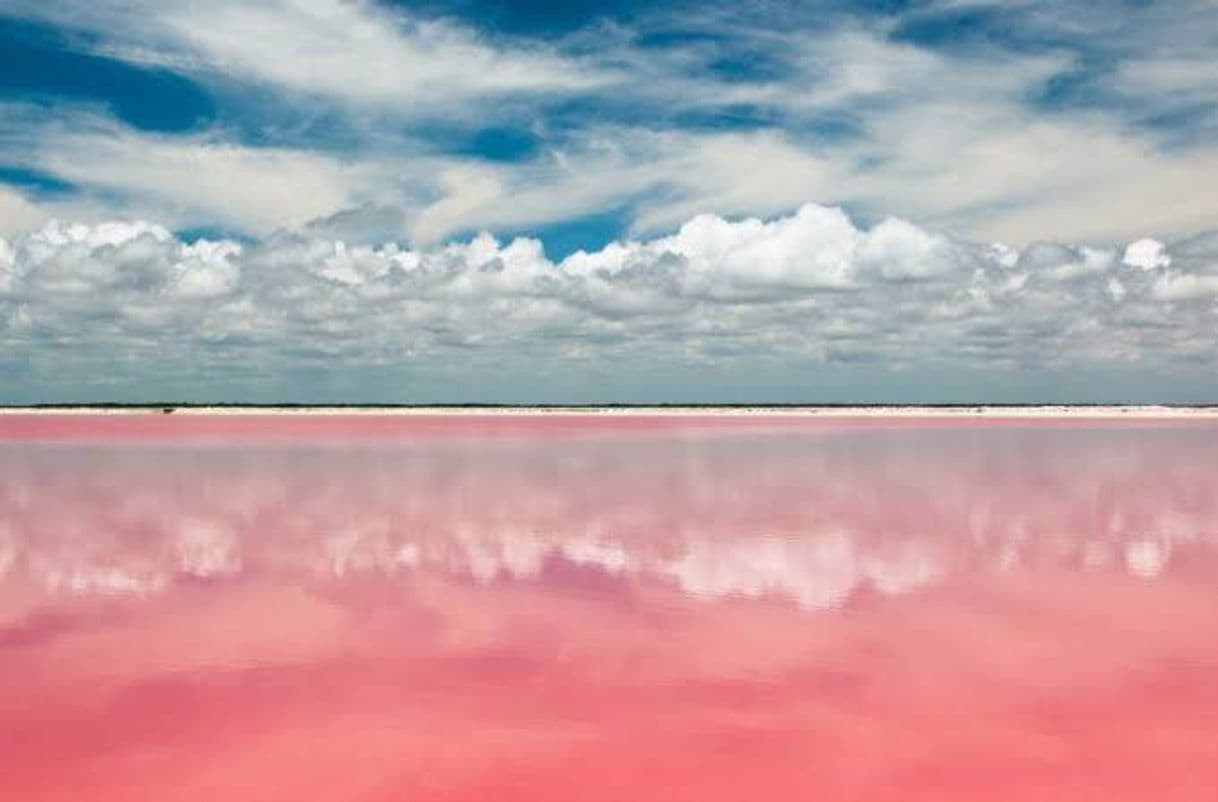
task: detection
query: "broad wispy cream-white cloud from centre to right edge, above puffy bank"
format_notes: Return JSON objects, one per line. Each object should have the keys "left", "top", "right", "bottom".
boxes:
{"left": 382, "top": 30, "right": 1218, "bottom": 245}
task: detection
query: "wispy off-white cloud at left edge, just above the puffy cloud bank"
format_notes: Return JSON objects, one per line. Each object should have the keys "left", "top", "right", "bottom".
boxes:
{"left": 0, "top": 104, "right": 423, "bottom": 236}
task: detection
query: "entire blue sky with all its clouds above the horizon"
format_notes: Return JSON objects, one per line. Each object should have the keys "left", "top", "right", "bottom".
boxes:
{"left": 0, "top": 0, "right": 1218, "bottom": 402}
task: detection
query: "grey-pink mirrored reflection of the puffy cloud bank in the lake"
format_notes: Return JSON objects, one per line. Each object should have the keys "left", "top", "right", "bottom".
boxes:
{"left": 0, "top": 428, "right": 1218, "bottom": 599}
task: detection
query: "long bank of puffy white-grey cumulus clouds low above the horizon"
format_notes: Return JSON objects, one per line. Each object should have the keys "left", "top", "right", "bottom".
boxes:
{"left": 0, "top": 205, "right": 1218, "bottom": 397}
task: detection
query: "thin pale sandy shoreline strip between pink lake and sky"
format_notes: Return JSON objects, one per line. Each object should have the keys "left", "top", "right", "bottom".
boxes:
{"left": 0, "top": 405, "right": 1218, "bottom": 418}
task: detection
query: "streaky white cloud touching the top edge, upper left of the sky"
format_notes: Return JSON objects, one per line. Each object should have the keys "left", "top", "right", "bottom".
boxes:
{"left": 2, "top": 0, "right": 609, "bottom": 110}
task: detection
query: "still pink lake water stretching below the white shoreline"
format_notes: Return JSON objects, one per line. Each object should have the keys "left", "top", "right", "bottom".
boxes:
{"left": 0, "top": 416, "right": 1218, "bottom": 802}
